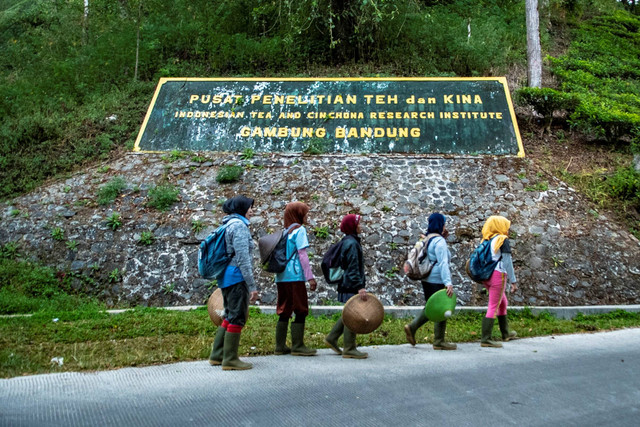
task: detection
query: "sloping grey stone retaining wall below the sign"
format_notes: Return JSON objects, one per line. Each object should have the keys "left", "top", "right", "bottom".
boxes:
{"left": 0, "top": 153, "right": 640, "bottom": 306}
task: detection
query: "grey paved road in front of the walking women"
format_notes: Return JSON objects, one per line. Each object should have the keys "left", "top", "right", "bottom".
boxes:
{"left": 0, "top": 329, "right": 640, "bottom": 426}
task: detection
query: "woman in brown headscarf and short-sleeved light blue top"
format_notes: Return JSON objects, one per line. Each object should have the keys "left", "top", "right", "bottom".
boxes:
{"left": 275, "top": 202, "right": 317, "bottom": 356}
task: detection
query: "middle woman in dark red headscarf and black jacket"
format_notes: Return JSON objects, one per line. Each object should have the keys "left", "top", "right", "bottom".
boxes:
{"left": 324, "top": 214, "right": 368, "bottom": 359}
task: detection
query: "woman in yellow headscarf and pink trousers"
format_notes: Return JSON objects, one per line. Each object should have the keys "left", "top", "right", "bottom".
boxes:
{"left": 481, "top": 216, "right": 518, "bottom": 348}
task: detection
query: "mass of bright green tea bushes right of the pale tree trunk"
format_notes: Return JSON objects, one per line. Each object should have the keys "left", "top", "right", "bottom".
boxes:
{"left": 549, "top": 11, "right": 640, "bottom": 142}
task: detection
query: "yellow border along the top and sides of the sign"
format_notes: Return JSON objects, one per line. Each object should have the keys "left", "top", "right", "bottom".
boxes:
{"left": 133, "top": 77, "right": 524, "bottom": 157}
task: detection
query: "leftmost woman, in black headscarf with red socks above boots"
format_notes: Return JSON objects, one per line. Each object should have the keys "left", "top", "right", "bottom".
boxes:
{"left": 209, "top": 196, "right": 258, "bottom": 371}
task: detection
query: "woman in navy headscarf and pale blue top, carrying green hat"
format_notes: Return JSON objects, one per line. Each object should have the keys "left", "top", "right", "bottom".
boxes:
{"left": 404, "top": 212, "right": 458, "bottom": 350}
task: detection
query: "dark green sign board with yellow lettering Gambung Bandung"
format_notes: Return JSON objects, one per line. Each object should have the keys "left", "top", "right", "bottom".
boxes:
{"left": 134, "top": 78, "right": 524, "bottom": 157}
